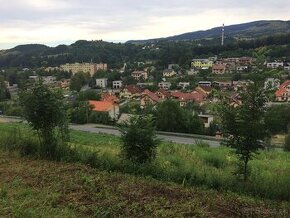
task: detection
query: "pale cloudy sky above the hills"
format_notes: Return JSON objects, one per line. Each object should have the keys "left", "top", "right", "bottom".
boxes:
{"left": 0, "top": 0, "right": 290, "bottom": 49}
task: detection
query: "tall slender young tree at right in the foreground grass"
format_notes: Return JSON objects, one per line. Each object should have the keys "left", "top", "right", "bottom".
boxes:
{"left": 221, "top": 84, "right": 267, "bottom": 181}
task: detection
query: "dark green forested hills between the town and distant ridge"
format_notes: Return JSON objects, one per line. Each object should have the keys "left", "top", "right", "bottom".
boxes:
{"left": 0, "top": 33, "right": 290, "bottom": 69}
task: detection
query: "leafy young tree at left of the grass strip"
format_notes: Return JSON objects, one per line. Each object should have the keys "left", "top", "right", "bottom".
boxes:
{"left": 20, "top": 81, "right": 68, "bottom": 159}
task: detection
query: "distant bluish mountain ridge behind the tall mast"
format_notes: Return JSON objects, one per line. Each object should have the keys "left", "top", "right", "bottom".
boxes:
{"left": 127, "top": 20, "right": 290, "bottom": 44}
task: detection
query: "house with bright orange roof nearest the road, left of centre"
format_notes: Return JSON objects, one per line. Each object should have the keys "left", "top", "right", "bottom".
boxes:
{"left": 89, "top": 101, "right": 120, "bottom": 120}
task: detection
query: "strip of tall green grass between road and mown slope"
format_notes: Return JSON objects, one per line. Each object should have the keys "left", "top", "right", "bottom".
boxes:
{"left": 0, "top": 125, "right": 290, "bottom": 200}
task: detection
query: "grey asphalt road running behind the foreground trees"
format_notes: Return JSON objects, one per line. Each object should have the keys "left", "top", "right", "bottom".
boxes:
{"left": 0, "top": 116, "right": 220, "bottom": 148}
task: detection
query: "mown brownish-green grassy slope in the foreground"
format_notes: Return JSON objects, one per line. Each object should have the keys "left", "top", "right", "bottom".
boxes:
{"left": 0, "top": 153, "right": 290, "bottom": 217}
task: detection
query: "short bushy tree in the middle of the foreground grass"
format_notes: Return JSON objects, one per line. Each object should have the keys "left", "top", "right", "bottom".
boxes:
{"left": 119, "top": 116, "right": 159, "bottom": 163}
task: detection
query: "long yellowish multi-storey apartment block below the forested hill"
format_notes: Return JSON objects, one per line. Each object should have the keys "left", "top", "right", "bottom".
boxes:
{"left": 59, "top": 63, "right": 108, "bottom": 76}
